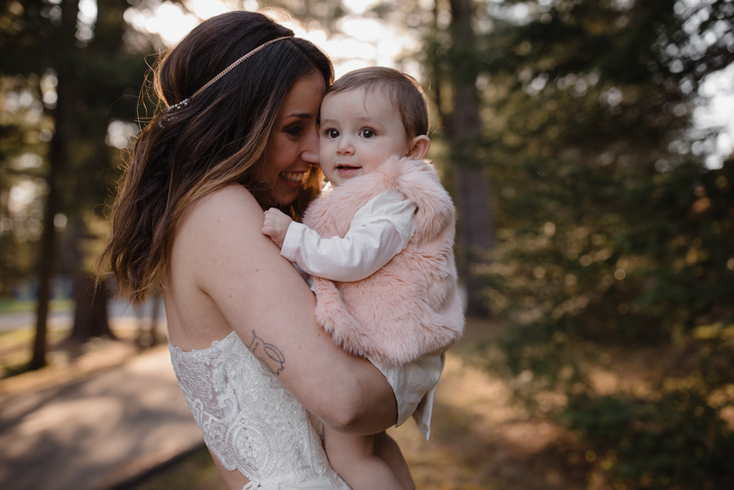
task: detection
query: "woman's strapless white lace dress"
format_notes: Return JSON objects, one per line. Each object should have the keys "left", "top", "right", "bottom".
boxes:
{"left": 169, "top": 332, "right": 349, "bottom": 490}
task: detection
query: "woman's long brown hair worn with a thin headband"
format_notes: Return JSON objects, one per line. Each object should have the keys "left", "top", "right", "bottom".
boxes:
{"left": 98, "top": 12, "right": 333, "bottom": 304}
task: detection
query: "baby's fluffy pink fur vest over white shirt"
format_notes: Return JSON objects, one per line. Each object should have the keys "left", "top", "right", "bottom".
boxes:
{"left": 303, "top": 157, "right": 464, "bottom": 364}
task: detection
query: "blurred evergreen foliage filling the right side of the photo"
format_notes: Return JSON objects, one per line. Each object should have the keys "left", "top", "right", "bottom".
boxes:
{"left": 458, "top": 0, "right": 734, "bottom": 488}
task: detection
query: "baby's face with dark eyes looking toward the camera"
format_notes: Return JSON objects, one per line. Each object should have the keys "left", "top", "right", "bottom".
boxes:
{"left": 319, "top": 89, "right": 410, "bottom": 185}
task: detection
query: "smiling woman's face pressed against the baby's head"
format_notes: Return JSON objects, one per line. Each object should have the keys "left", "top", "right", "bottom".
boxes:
{"left": 256, "top": 72, "right": 326, "bottom": 205}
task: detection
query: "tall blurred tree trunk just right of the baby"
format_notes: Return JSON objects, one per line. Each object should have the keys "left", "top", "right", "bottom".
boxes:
{"left": 448, "top": 0, "right": 495, "bottom": 317}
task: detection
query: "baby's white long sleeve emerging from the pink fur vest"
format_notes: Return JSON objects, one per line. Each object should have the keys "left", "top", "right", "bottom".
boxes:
{"left": 280, "top": 190, "right": 416, "bottom": 282}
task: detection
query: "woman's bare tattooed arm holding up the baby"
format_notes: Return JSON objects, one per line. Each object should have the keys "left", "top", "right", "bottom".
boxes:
{"left": 175, "top": 186, "right": 397, "bottom": 434}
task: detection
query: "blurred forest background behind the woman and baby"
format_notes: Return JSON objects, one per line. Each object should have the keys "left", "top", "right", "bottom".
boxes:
{"left": 0, "top": 0, "right": 734, "bottom": 489}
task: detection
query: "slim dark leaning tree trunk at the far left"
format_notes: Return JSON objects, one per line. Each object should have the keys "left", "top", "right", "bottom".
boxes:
{"left": 28, "top": 0, "right": 79, "bottom": 370}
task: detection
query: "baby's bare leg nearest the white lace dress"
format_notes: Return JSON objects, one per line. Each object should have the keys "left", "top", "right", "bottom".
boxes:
{"left": 324, "top": 427, "right": 406, "bottom": 490}
